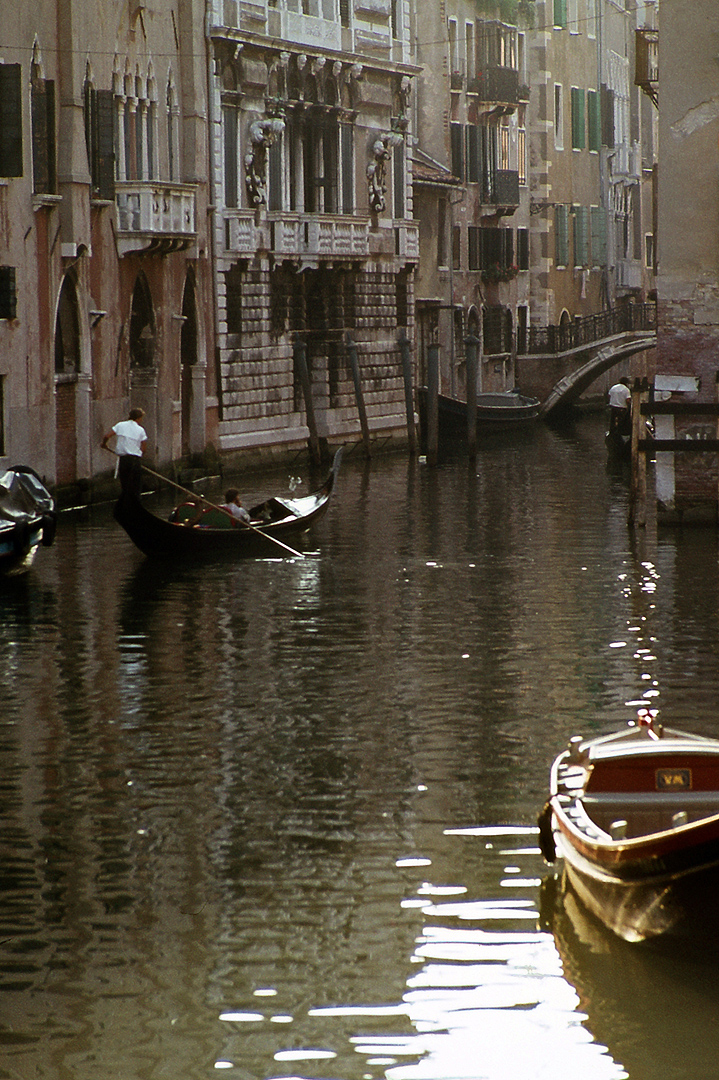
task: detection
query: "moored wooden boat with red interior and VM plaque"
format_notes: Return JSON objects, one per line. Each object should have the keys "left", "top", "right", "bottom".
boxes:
{"left": 539, "top": 715, "right": 719, "bottom": 942}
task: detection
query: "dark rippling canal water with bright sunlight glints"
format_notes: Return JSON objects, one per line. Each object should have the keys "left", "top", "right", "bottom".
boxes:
{"left": 0, "top": 417, "right": 719, "bottom": 1080}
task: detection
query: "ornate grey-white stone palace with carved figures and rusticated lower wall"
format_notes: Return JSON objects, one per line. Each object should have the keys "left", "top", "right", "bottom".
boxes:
{"left": 208, "top": 0, "right": 419, "bottom": 460}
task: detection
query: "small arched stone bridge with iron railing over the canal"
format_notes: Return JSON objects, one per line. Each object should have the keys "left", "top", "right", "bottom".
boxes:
{"left": 515, "top": 303, "right": 656, "bottom": 417}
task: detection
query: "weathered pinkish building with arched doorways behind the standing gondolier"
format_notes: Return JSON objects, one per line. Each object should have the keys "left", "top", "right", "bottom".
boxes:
{"left": 0, "top": 0, "right": 215, "bottom": 489}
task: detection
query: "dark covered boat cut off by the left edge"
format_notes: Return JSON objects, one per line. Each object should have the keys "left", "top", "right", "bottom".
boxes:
{"left": 0, "top": 465, "right": 57, "bottom": 577}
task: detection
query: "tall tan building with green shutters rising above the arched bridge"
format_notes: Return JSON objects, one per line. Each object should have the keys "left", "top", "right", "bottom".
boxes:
{"left": 529, "top": 0, "right": 656, "bottom": 326}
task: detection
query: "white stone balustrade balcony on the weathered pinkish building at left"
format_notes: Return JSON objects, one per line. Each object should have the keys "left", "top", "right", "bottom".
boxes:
{"left": 114, "top": 180, "right": 196, "bottom": 255}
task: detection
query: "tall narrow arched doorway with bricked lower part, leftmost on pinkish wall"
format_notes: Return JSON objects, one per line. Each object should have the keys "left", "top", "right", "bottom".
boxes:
{"left": 55, "top": 274, "right": 81, "bottom": 484}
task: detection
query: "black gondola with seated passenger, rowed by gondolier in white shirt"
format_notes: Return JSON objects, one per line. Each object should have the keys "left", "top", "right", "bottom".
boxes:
{"left": 114, "top": 448, "right": 342, "bottom": 559}
